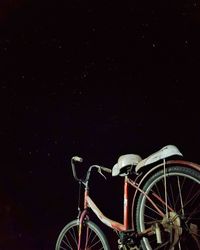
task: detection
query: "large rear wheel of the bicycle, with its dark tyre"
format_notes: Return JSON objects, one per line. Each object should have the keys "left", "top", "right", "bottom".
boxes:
{"left": 136, "top": 166, "right": 200, "bottom": 250}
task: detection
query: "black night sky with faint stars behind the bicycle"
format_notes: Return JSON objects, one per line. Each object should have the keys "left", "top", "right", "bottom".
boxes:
{"left": 0, "top": 0, "right": 200, "bottom": 250}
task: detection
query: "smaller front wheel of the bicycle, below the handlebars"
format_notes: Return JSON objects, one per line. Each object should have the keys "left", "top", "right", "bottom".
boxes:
{"left": 56, "top": 220, "right": 110, "bottom": 250}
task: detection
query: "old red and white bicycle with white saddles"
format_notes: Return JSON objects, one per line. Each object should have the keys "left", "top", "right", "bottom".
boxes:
{"left": 56, "top": 145, "right": 200, "bottom": 250}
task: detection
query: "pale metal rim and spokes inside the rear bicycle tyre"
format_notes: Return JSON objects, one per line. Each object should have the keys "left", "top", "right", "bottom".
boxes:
{"left": 139, "top": 171, "right": 200, "bottom": 250}
